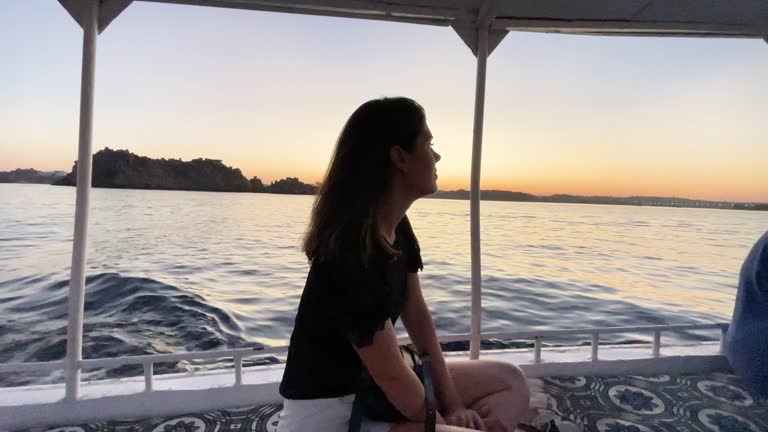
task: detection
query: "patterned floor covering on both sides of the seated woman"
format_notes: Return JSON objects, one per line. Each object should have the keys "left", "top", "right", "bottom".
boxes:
{"left": 13, "top": 373, "right": 768, "bottom": 432}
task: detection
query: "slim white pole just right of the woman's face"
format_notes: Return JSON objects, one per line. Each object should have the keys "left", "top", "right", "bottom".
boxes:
{"left": 469, "top": 23, "right": 489, "bottom": 360}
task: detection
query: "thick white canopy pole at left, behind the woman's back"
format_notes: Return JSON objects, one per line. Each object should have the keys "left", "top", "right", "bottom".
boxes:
{"left": 65, "top": 0, "right": 99, "bottom": 401}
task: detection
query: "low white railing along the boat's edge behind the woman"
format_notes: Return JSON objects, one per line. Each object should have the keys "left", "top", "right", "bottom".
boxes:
{"left": 0, "top": 323, "right": 729, "bottom": 392}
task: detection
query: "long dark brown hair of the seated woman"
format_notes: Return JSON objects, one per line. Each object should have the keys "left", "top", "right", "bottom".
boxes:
{"left": 303, "top": 97, "right": 426, "bottom": 265}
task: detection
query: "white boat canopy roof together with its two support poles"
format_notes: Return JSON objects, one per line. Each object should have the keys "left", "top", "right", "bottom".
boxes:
{"left": 51, "top": 0, "right": 768, "bottom": 401}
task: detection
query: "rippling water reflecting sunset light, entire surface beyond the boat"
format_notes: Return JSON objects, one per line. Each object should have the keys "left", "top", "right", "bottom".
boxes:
{"left": 0, "top": 184, "right": 768, "bottom": 384}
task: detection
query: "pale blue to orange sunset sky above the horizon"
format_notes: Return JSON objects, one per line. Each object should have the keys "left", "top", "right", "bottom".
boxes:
{"left": 0, "top": 0, "right": 768, "bottom": 202}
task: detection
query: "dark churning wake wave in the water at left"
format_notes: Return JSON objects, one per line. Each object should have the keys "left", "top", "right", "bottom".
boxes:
{"left": 0, "top": 273, "right": 279, "bottom": 386}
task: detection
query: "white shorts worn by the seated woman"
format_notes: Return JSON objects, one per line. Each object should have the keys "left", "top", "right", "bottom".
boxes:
{"left": 277, "top": 394, "right": 393, "bottom": 432}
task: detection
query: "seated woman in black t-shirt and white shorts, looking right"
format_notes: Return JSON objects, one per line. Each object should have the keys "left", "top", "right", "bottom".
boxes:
{"left": 278, "top": 98, "right": 529, "bottom": 432}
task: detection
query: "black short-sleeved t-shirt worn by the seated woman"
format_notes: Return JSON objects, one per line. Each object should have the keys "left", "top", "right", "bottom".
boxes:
{"left": 280, "top": 217, "right": 423, "bottom": 399}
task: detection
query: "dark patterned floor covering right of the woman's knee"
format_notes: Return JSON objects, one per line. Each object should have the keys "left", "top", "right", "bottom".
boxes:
{"left": 543, "top": 373, "right": 768, "bottom": 432}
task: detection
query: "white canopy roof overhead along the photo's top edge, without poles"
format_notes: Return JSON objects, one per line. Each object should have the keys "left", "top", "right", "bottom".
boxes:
{"left": 142, "top": 0, "right": 768, "bottom": 38}
